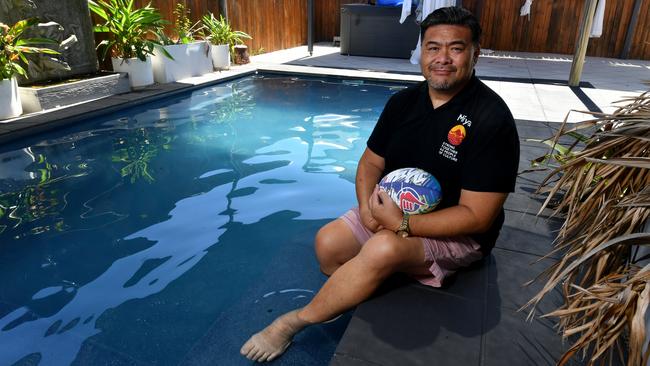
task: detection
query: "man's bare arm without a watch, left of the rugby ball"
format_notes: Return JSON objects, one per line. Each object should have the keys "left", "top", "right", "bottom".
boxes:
{"left": 355, "top": 148, "right": 385, "bottom": 232}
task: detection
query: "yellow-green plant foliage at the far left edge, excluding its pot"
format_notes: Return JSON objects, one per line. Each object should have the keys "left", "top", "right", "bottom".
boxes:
{"left": 0, "top": 18, "right": 60, "bottom": 80}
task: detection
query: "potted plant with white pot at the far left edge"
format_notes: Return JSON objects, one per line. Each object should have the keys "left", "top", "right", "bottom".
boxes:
{"left": 0, "top": 18, "right": 59, "bottom": 120}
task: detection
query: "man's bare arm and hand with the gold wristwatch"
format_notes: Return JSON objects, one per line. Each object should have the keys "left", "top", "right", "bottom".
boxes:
{"left": 370, "top": 188, "right": 508, "bottom": 237}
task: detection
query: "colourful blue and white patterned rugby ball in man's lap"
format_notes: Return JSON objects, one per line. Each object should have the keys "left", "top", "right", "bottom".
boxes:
{"left": 379, "top": 168, "right": 442, "bottom": 215}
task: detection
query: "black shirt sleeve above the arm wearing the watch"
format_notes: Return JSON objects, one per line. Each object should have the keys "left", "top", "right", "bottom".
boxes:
{"left": 461, "top": 111, "right": 519, "bottom": 193}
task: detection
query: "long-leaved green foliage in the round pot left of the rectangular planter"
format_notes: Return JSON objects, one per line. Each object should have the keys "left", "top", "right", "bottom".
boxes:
{"left": 88, "top": 0, "right": 172, "bottom": 61}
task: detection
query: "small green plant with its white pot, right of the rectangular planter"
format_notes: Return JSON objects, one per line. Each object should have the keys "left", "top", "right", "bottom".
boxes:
{"left": 201, "top": 13, "right": 251, "bottom": 69}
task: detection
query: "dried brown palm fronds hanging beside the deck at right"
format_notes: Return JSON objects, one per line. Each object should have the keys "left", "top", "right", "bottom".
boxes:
{"left": 522, "top": 87, "right": 650, "bottom": 365}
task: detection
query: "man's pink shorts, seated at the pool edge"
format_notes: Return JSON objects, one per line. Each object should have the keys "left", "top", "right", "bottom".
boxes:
{"left": 341, "top": 207, "right": 483, "bottom": 287}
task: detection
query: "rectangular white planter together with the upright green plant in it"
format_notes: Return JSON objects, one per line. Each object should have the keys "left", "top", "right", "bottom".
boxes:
{"left": 152, "top": 3, "right": 212, "bottom": 83}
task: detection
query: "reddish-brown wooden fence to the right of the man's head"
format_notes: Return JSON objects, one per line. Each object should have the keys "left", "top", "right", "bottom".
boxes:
{"left": 463, "top": 0, "right": 650, "bottom": 59}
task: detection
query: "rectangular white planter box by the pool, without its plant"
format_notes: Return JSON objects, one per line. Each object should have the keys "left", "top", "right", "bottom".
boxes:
{"left": 152, "top": 41, "right": 212, "bottom": 83}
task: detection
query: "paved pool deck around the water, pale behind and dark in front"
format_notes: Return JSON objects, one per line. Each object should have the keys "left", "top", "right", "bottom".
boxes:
{"left": 0, "top": 45, "right": 650, "bottom": 366}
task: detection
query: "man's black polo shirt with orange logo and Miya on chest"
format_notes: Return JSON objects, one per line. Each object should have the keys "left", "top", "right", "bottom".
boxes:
{"left": 368, "top": 76, "right": 519, "bottom": 255}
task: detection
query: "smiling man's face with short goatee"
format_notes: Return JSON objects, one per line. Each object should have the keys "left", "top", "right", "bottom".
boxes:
{"left": 420, "top": 24, "right": 479, "bottom": 92}
